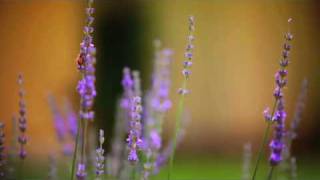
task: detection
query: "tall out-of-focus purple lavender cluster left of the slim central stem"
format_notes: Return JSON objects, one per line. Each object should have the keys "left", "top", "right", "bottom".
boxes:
{"left": 144, "top": 40, "right": 173, "bottom": 179}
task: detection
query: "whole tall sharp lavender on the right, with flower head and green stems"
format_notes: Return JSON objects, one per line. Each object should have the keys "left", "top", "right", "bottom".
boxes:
{"left": 252, "top": 18, "right": 293, "bottom": 180}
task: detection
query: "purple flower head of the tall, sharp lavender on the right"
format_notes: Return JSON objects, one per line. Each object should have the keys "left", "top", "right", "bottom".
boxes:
{"left": 264, "top": 19, "right": 293, "bottom": 166}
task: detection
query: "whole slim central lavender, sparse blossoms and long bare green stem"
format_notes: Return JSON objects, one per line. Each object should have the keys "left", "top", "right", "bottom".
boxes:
{"left": 168, "top": 16, "right": 195, "bottom": 180}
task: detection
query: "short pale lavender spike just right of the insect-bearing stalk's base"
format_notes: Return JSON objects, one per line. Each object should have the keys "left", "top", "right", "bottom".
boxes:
{"left": 96, "top": 129, "right": 105, "bottom": 177}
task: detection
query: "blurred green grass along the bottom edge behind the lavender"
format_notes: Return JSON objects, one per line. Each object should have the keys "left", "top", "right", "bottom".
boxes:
{"left": 16, "top": 154, "right": 320, "bottom": 180}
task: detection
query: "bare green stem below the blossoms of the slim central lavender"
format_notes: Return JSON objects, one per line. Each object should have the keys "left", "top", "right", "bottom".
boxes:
{"left": 168, "top": 79, "right": 187, "bottom": 180}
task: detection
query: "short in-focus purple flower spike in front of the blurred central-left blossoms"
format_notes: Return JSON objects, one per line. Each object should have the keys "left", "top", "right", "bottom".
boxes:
{"left": 127, "top": 96, "right": 143, "bottom": 163}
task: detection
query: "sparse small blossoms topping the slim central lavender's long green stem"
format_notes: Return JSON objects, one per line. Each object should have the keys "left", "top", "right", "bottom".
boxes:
{"left": 178, "top": 16, "right": 195, "bottom": 95}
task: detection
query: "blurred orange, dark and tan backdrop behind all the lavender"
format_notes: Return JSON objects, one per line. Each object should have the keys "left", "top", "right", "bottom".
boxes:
{"left": 0, "top": 0, "right": 320, "bottom": 180}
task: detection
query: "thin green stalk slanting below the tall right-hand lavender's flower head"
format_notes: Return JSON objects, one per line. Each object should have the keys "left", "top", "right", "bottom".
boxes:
{"left": 252, "top": 100, "right": 278, "bottom": 180}
